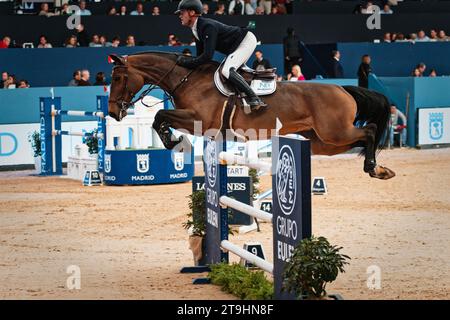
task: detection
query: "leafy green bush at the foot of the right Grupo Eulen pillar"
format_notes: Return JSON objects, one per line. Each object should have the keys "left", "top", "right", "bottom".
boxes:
{"left": 283, "top": 236, "right": 350, "bottom": 299}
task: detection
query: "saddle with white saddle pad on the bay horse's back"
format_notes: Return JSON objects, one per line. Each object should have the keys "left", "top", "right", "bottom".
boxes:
{"left": 214, "top": 61, "right": 277, "bottom": 97}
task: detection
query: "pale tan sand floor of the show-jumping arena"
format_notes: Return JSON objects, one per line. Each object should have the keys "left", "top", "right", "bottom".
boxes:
{"left": 0, "top": 149, "right": 450, "bottom": 299}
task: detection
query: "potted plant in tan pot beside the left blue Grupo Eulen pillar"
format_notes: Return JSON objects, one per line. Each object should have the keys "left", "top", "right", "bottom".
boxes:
{"left": 183, "top": 190, "right": 206, "bottom": 266}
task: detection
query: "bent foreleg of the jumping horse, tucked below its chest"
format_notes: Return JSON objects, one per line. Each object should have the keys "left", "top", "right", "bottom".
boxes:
{"left": 153, "top": 110, "right": 195, "bottom": 150}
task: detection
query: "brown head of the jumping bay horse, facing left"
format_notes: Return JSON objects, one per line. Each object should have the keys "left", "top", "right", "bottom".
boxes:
{"left": 108, "top": 55, "right": 145, "bottom": 121}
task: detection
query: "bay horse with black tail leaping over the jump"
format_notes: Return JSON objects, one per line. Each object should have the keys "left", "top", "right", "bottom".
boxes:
{"left": 108, "top": 52, "right": 395, "bottom": 179}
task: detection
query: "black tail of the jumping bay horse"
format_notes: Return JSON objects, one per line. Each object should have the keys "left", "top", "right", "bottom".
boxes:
{"left": 343, "top": 86, "right": 391, "bottom": 155}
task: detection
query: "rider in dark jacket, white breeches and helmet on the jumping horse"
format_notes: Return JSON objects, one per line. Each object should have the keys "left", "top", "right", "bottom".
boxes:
{"left": 175, "top": 0, "right": 267, "bottom": 109}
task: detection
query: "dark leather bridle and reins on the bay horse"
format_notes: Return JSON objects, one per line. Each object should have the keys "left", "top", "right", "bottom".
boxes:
{"left": 109, "top": 57, "right": 195, "bottom": 119}
